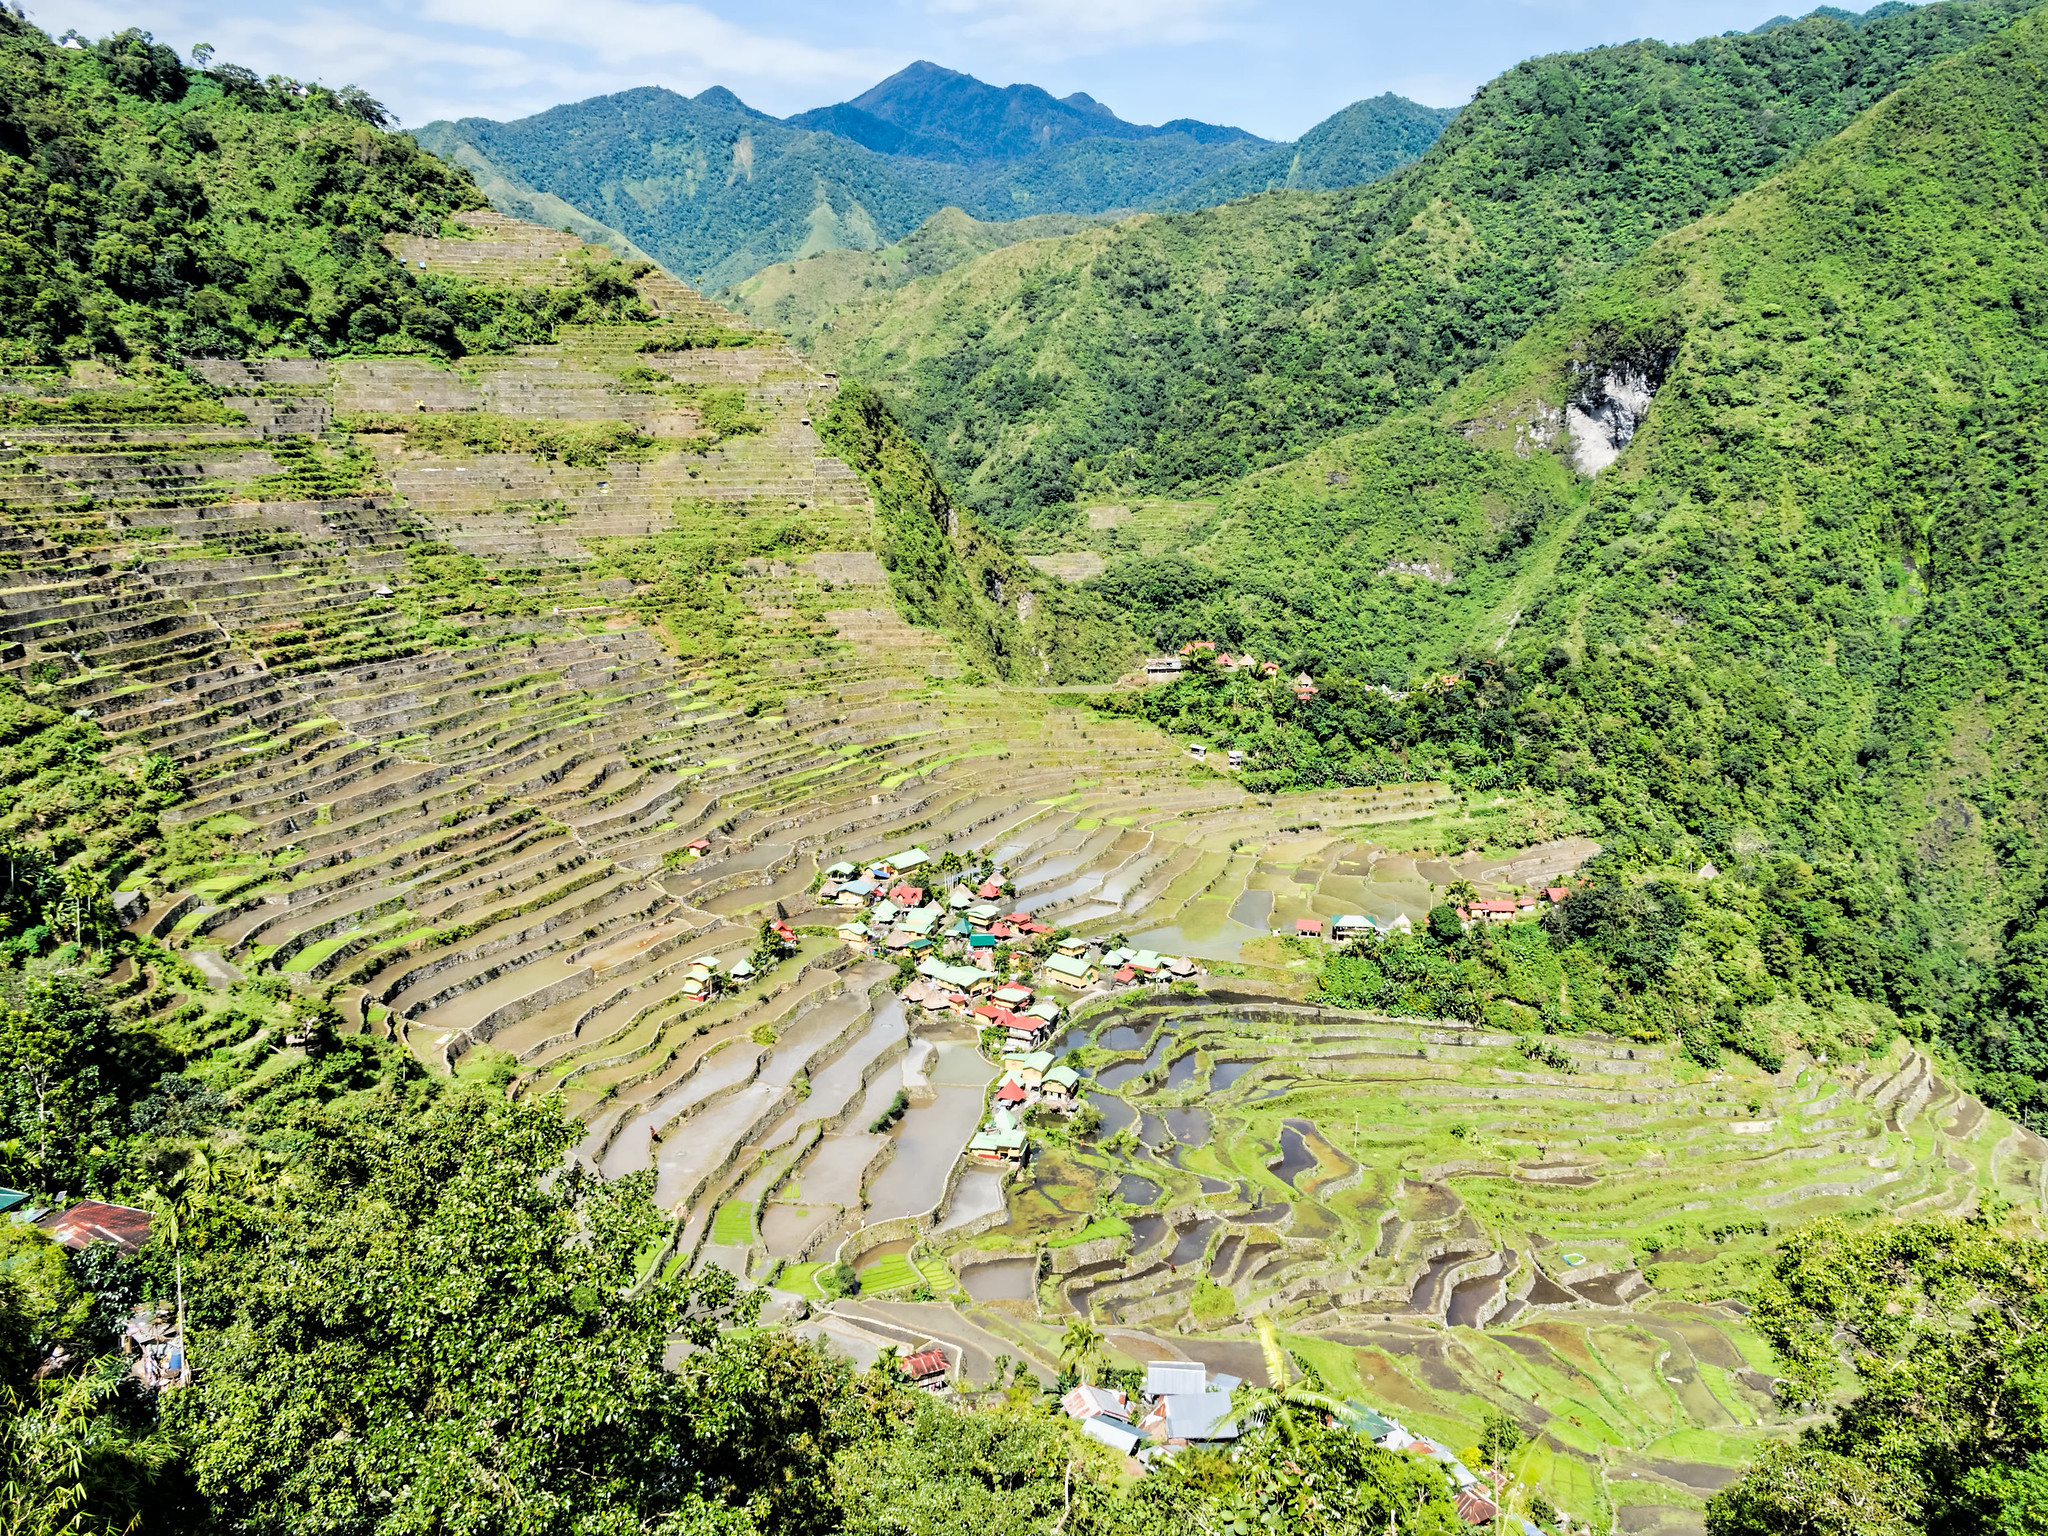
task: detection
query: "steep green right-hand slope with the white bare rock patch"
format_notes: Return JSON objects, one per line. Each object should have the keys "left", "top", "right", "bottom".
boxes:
{"left": 1098, "top": 6, "right": 2048, "bottom": 1116}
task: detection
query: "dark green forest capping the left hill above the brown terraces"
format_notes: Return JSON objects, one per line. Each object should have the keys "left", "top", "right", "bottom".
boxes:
{"left": 0, "top": 12, "right": 671, "bottom": 362}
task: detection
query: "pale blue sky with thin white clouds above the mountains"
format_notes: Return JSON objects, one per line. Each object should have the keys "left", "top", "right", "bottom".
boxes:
{"left": 27, "top": 0, "right": 1826, "bottom": 139}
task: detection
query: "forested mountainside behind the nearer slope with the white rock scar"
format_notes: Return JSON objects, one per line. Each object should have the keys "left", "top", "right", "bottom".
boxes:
{"left": 817, "top": 0, "right": 2025, "bottom": 526}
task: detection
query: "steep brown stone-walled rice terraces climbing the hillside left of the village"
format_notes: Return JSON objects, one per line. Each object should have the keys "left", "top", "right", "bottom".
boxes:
{"left": 0, "top": 215, "right": 1433, "bottom": 1261}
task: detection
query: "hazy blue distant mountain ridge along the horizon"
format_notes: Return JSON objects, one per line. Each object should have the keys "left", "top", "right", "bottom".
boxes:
{"left": 414, "top": 63, "right": 1450, "bottom": 289}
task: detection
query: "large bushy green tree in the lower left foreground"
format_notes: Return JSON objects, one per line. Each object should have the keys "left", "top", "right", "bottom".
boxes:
{"left": 164, "top": 1094, "right": 766, "bottom": 1536}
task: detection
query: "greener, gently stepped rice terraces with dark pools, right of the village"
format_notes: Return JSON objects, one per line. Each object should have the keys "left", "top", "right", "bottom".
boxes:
{"left": 770, "top": 997, "right": 2048, "bottom": 1534}
